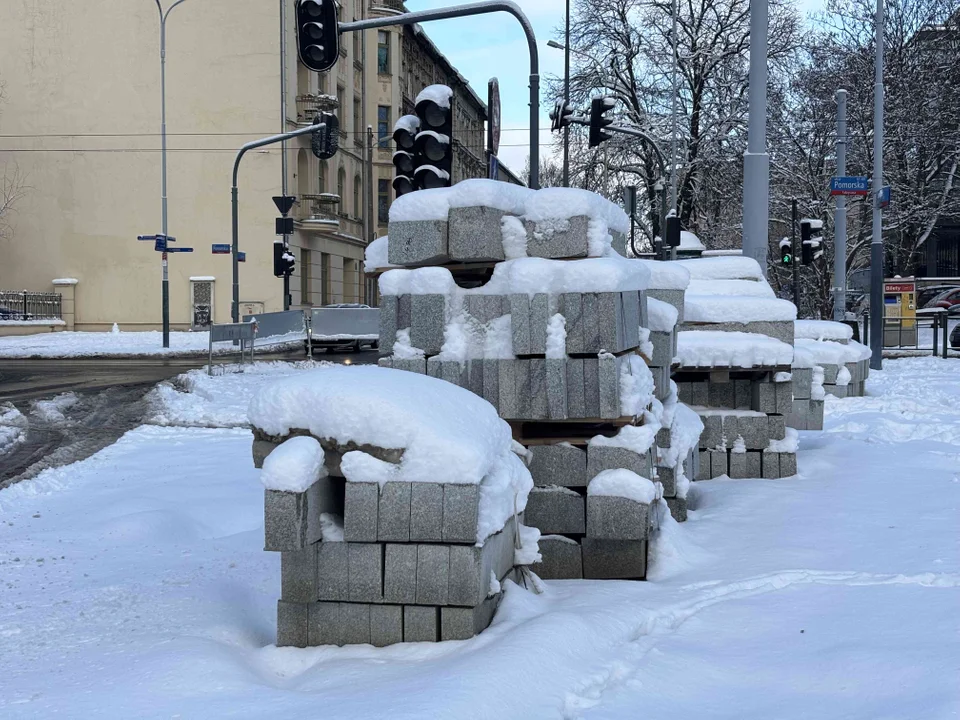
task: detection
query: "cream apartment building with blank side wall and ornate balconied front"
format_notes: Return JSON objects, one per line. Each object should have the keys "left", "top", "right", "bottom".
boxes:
{"left": 0, "top": 0, "right": 486, "bottom": 330}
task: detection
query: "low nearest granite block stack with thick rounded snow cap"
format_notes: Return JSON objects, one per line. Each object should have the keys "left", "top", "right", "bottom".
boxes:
{"left": 249, "top": 367, "right": 538, "bottom": 647}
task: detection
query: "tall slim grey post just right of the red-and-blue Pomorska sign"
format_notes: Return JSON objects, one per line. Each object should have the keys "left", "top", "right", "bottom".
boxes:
{"left": 870, "top": 0, "right": 884, "bottom": 370}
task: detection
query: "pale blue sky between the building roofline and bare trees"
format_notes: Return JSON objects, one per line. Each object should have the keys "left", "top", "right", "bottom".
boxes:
{"left": 406, "top": 0, "right": 823, "bottom": 174}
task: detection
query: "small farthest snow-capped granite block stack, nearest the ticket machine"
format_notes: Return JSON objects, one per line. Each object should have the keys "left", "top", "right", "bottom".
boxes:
{"left": 794, "top": 320, "right": 870, "bottom": 400}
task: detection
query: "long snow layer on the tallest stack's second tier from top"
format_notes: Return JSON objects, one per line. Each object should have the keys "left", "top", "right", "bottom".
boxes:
{"left": 380, "top": 255, "right": 650, "bottom": 295}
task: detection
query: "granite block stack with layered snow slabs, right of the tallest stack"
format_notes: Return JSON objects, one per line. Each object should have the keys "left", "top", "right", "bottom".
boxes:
{"left": 674, "top": 257, "right": 797, "bottom": 480}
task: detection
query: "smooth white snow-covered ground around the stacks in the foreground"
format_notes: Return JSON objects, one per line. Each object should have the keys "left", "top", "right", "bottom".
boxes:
{"left": 0, "top": 358, "right": 960, "bottom": 720}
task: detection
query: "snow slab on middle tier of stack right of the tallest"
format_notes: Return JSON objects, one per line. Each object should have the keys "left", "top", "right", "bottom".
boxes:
{"left": 677, "top": 330, "right": 793, "bottom": 368}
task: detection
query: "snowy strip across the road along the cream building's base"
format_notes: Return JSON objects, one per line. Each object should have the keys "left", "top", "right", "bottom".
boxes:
{"left": 0, "top": 330, "right": 303, "bottom": 358}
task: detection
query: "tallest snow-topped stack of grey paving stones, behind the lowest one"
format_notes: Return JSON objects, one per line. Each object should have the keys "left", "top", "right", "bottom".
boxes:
{"left": 380, "top": 181, "right": 668, "bottom": 579}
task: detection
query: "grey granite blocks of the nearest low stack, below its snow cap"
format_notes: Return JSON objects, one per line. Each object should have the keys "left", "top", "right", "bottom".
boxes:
{"left": 253, "top": 368, "right": 535, "bottom": 647}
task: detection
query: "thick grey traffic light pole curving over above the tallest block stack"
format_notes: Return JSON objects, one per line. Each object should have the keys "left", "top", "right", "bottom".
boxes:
{"left": 339, "top": 0, "right": 540, "bottom": 190}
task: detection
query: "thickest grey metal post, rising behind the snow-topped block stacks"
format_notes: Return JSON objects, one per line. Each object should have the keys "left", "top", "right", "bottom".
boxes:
{"left": 743, "top": 0, "right": 770, "bottom": 277}
